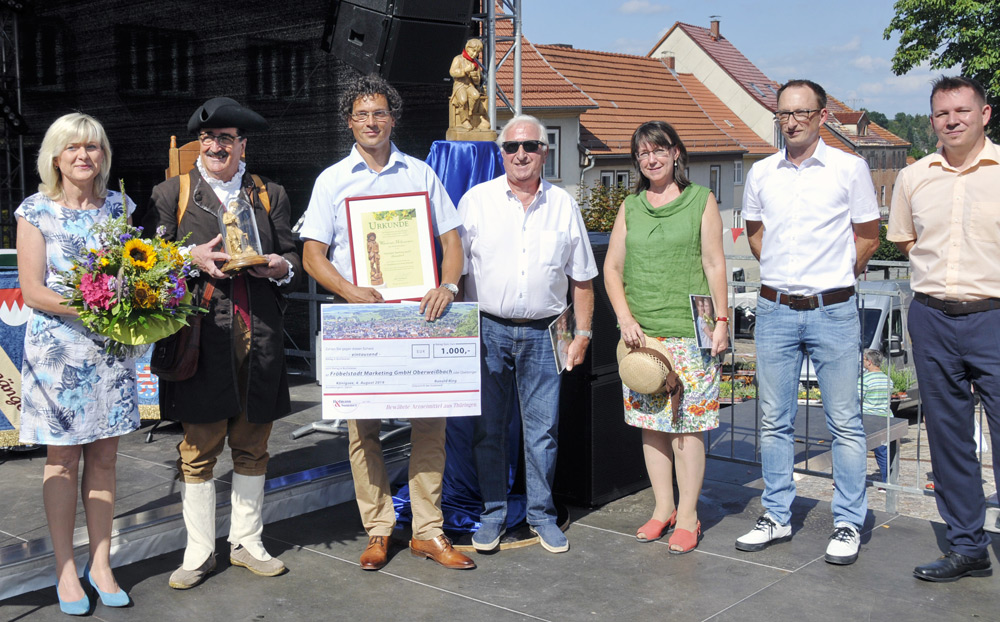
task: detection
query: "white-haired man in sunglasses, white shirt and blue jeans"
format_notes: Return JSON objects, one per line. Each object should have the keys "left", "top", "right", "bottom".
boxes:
{"left": 458, "top": 115, "right": 597, "bottom": 553}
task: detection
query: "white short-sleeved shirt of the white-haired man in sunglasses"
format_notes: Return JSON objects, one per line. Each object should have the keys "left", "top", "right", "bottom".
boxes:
{"left": 458, "top": 176, "right": 597, "bottom": 320}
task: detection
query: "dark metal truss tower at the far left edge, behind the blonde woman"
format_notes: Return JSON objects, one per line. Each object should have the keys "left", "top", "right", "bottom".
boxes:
{"left": 0, "top": 5, "right": 24, "bottom": 248}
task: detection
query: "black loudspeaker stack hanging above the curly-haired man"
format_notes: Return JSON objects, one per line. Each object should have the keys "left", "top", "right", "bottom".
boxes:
{"left": 323, "top": 0, "right": 471, "bottom": 84}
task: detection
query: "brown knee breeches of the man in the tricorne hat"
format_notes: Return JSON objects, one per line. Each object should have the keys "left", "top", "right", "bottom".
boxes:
{"left": 177, "top": 314, "right": 272, "bottom": 484}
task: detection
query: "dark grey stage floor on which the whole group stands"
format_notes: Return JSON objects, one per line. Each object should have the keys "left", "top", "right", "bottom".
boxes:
{"left": 0, "top": 383, "right": 1000, "bottom": 622}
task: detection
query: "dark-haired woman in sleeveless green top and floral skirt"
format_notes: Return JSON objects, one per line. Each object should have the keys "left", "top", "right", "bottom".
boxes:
{"left": 604, "top": 121, "right": 729, "bottom": 553}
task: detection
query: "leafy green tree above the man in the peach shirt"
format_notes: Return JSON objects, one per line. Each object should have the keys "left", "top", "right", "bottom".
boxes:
{"left": 882, "top": 0, "right": 1000, "bottom": 141}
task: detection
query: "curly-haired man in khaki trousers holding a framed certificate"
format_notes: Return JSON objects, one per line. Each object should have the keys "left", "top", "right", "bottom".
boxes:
{"left": 300, "top": 75, "right": 476, "bottom": 570}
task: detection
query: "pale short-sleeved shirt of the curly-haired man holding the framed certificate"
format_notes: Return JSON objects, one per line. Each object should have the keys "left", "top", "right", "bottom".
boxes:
{"left": 299, "top": 145, "right": 461, "bottom": 283}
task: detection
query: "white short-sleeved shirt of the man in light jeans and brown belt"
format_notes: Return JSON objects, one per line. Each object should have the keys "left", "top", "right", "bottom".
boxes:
{"left": 743, "top": 139, "right": 879, "bottom": 296}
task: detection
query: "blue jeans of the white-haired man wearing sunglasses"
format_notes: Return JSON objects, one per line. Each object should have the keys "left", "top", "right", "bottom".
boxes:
{"left": 472, "top": 315, "right": 561, "bottom": 525}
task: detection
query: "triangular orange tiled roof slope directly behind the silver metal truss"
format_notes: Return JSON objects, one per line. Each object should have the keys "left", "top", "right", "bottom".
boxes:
{"left": 496, "top": 15, "right": 597, "bottom": 113}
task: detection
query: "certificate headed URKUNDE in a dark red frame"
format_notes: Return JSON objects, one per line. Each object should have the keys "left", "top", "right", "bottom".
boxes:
{"left": 346, "top": 192, "right": 438, "bottom": 302}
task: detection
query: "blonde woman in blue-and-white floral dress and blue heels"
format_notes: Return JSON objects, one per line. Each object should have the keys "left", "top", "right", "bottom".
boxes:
{"left": 15, "top": 113, "right": 139, "bottom": 615}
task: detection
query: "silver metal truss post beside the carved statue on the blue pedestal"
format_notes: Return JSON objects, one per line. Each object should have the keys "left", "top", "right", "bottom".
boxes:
{"left": 472, "top": 0, "right": 522, "bottom": 130}
